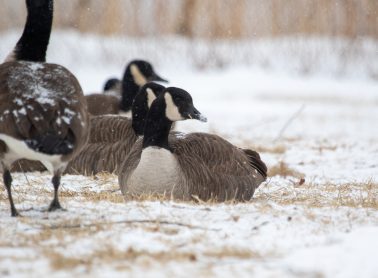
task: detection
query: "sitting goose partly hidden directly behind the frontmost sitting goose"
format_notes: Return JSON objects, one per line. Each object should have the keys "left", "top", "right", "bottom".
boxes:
{"left": 66, "top": 82, "right": 165, "bottom": 175}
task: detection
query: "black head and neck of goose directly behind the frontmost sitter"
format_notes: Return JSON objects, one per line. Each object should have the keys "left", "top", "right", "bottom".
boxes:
{"left": 131, "top": 82, "right": 165, "bottom": 136}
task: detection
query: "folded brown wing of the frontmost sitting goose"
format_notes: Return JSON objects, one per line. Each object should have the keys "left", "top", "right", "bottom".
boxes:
{"left": 170, "top": 133, "right": 265, "bottom": 201}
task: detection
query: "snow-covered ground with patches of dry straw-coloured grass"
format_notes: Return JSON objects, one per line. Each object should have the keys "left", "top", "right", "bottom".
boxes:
{"left": 0, "top": 33, "right": 378, "bottom": 277}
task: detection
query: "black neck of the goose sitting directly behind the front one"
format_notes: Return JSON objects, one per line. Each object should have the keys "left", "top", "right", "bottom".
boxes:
{"left": 131, "top": 93, "right": 149, "bottom": 136}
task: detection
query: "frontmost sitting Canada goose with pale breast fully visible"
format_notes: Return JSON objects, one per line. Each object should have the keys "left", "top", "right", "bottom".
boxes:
{"left": 118, "top": 87, "right": 267, "bottom": 201}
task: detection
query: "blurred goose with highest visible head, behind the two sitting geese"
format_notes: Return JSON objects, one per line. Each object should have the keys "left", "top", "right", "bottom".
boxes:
{"left": 85, "top": 60, "right": 167, "bottom": 116}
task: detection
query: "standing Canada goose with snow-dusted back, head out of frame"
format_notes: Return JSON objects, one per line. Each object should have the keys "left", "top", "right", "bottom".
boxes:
{"left": 0, "top": 0, "right": 88, "bottom": 216}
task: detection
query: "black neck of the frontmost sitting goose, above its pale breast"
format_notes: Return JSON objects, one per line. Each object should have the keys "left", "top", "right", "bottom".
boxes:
{"left": 143, "top": 98, "right": 172, "bottom": 151}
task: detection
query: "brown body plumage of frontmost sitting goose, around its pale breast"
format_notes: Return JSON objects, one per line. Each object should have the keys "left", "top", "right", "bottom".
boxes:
{"left": 119, "top": 133, "right": 266, "bottom": 201}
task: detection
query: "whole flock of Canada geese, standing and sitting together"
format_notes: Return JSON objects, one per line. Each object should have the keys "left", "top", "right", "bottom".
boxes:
{"left": 0, "top": 0, "right": 267, "bottom": 216}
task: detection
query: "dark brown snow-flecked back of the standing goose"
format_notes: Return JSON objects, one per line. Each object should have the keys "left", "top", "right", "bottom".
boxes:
{"left": 0, "top": 61, "right": 88, "bottom": 161}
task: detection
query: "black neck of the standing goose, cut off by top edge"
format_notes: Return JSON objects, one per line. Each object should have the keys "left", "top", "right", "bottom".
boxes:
{"left": 14, "top": 0, "right": 53, "bottom": 62}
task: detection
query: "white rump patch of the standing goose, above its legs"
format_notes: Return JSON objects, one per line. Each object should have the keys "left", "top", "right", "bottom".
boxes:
{"left": 0, "top": 134, "right": 64, "bottom": 173}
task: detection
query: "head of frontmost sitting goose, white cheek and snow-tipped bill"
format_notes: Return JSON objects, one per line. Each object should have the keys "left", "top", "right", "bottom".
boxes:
{"left": 163, "top": 87, "right": 207, "bottom": 122}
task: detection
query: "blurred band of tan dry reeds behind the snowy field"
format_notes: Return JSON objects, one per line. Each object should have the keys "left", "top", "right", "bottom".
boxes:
{"left": 0, "top": 0, "right": 378, "bottom": 39}
